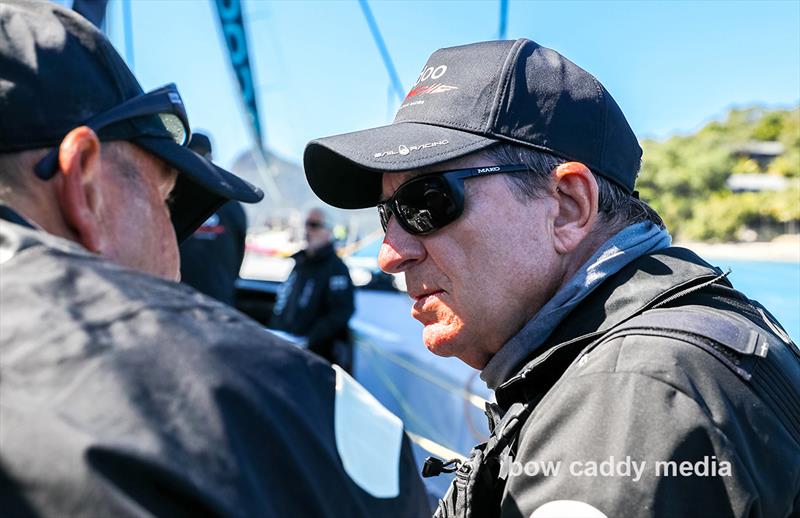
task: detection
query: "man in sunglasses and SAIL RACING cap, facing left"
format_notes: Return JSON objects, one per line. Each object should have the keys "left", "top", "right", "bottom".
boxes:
{"left": 304, "top": 39, "right": 800, "bottom": 517}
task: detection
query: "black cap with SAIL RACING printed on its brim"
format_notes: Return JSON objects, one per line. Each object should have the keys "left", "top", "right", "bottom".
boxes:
{"left": 303, "top": 39, "right": 642, "bottom": 209}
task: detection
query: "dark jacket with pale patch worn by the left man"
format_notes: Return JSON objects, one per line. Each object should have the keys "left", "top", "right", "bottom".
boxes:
{"left": 0, "top": 213, "right": 429, "bottom": 517}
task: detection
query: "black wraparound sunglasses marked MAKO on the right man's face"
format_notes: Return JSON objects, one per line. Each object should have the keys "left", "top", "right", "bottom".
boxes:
{"left": 378, "top": 165, "right": 528, "bottom": 235}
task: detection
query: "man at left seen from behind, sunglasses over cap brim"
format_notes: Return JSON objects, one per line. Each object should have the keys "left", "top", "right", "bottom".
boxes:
{"left": 0, "top": 0, "right": 428, "bottom": 517}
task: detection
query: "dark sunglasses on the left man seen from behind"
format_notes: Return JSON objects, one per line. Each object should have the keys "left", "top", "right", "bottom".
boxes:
{"left": 34, "top": 83, "right": 191, "bottom": 180}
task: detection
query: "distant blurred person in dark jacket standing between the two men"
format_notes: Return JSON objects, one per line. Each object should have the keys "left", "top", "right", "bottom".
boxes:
{"left": 270, "top": 208, "right": 355, "bottom": 372}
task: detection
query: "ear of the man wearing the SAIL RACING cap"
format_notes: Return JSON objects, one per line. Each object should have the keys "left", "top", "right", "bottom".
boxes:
{"left": 553, "top": 162, "right": 598, "bottom": 254}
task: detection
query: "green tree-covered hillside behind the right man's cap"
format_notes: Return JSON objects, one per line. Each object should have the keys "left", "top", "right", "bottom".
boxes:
{"left": 637, "top": 107, "right": 800, "bottom": 241}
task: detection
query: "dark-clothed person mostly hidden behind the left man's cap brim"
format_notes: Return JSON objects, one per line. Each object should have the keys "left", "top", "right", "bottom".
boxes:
{"left": 180, "top": 133, "right": 247, "bottom": 306}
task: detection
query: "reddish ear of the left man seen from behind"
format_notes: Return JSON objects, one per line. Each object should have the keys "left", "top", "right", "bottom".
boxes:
{"left": 56, "top": 126, "right": 103, "bottom": 252}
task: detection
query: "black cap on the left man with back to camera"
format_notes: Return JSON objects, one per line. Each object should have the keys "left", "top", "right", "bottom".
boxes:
{"left": 0, "top": 0, "right": 263, "bottom": 240}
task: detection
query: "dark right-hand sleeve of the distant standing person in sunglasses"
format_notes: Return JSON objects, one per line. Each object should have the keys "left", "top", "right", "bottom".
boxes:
{"left": 308, "top": 263, "right": 355, "bottom": 352}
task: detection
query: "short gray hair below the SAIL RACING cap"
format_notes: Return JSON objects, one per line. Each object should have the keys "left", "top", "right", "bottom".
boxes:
{"left": 483, "top": 142, "right": 664, "bottom": 230}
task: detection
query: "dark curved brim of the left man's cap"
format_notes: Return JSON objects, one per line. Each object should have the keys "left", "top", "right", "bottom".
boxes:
{"left": 132, "top": 137, "right": 264, "bottom": 242}
